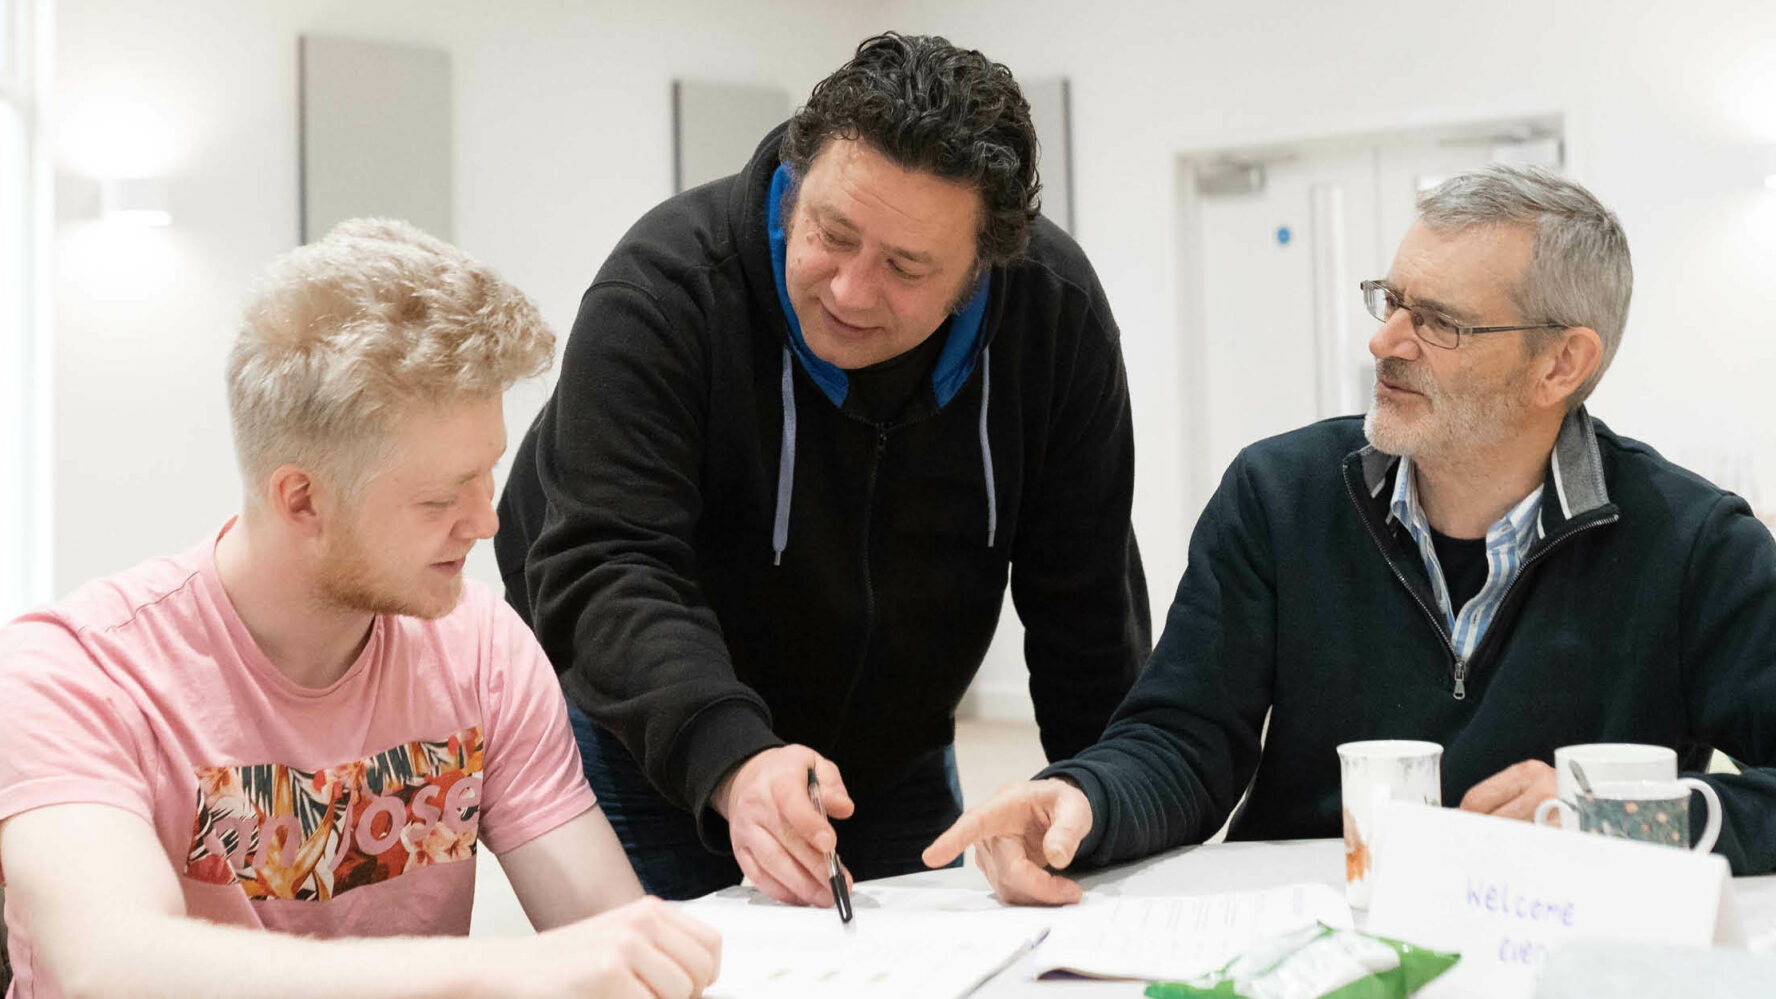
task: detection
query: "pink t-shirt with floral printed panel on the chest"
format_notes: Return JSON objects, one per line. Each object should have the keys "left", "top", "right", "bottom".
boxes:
{"left": 0, "top": 528, "right": 593, "bottom": 999}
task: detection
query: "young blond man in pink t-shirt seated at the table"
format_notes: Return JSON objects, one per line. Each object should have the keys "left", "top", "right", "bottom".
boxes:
{"left": 0, "top": 220, "right": 719, "bottom": 999}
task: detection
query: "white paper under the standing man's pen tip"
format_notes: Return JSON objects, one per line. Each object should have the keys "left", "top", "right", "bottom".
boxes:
{"left": 682, "top": 891, "right": 1051, "bottom": 999}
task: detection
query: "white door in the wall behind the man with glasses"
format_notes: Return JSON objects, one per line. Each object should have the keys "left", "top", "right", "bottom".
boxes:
{"left": 1185, "top": 127, "right": 1558, "bottom": 508}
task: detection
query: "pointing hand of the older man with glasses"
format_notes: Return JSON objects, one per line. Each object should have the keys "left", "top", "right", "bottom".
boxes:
{"left": 924, "top": 779, "right": 1092, "bottom": 905}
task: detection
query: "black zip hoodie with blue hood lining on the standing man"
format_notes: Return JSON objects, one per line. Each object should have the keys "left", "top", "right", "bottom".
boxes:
{"left": 494, "top": 120, "right": 1151, "bottom": 850}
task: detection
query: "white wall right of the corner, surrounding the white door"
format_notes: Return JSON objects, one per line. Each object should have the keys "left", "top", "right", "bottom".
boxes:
{"left": 893, "top": 0, "right": 1776, "bottom": 718}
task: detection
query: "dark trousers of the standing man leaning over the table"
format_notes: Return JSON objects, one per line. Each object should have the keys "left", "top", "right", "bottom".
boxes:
{"left": 567, "top": 700, "right": 963, "bottom": 899}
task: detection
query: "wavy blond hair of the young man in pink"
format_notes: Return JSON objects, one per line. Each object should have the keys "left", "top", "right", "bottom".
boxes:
{"left": 227, "top": 219, "right": 554, "bottom": 507}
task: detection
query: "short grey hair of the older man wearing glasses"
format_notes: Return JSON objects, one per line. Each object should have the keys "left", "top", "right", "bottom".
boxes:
{"left": 1419, "top": 164, "right": 1634, "bottom": 409}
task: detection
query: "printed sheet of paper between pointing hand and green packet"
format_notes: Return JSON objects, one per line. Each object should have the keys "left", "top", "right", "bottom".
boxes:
{"left": 1030, "top": 883, "right": 1352, "bottom": 981}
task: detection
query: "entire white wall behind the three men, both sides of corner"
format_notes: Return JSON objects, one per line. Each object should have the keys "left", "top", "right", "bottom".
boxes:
{"left": 55, "top": 0, "right": 1776, "bottom": 711}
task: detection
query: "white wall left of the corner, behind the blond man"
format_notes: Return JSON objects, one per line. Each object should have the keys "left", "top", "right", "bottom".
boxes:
{"left": 53, "top": 0, "right": 877, "bottom": 594}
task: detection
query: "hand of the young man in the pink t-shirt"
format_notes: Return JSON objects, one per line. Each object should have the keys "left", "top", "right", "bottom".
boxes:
{"left": 511, "top": 896, "right": 721, "bottom": 999}
